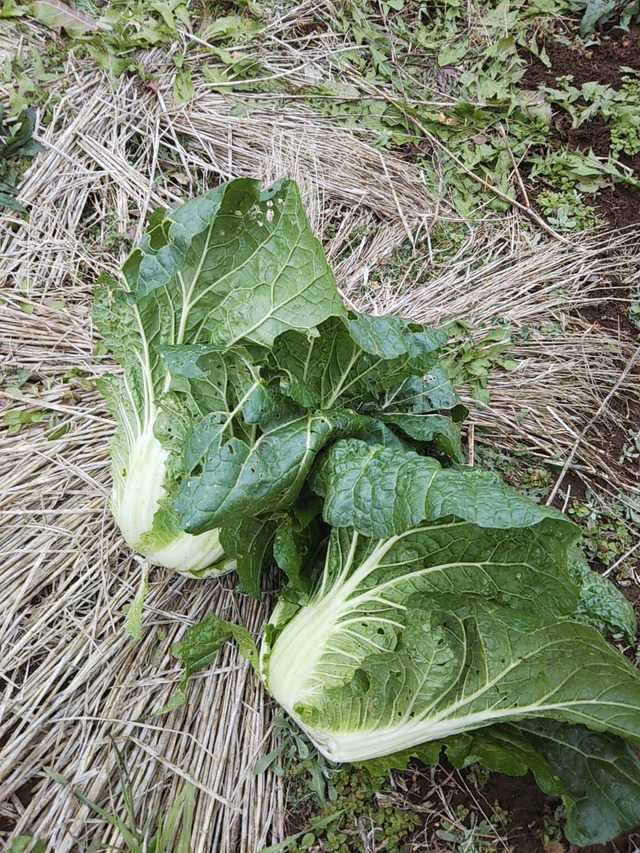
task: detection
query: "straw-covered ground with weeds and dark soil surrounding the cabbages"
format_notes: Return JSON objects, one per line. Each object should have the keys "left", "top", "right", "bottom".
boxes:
{"left": 0, "top": 0, "right": 640, "bottom": 853}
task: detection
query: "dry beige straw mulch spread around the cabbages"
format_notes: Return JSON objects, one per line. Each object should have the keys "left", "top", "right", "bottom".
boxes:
{"left": 0, "top": 33, "right": 640, "bottom": 853}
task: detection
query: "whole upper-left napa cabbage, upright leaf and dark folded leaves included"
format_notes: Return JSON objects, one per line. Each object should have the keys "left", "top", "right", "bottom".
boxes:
{"left": 94, "top": 179, "right": 466, "bottom": 580}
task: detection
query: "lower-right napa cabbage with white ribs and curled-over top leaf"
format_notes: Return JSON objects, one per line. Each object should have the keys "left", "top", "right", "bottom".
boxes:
{"left": 261, "top": 440, "right": 640, "bottom": 840}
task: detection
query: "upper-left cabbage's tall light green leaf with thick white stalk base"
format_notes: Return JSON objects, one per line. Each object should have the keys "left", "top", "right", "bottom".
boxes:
{"left": 94, "top": 179, "right": 344, "bottom": 575}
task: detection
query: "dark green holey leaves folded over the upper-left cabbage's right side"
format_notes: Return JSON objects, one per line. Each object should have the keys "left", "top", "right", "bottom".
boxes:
{"left": 165, "top": 313, "right": 462, "bottom": 594}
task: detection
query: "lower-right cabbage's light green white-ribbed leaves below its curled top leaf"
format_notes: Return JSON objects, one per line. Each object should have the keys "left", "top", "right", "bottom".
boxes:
{"left": 261, "top": 518, "right": 640, "bottom": 761}
